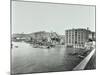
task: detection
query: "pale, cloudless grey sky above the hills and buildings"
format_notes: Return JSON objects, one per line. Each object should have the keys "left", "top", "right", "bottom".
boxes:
{"left": 12, "top": 1, "right": 95, "bottom": 34}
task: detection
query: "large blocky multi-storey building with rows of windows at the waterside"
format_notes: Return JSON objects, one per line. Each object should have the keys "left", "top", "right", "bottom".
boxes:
{"left": 65, "top": 28, "right": 92, "bottom": 48}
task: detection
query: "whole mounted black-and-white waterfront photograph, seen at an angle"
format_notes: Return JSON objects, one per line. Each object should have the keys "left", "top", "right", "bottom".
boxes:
{"left": 11, "top": 0, "right": 96, "bottom": 75}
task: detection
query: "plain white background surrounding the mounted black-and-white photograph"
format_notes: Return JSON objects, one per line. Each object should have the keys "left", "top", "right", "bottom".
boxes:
{"left": 0, "top": 0, "right": 100, "bottom": 75}
